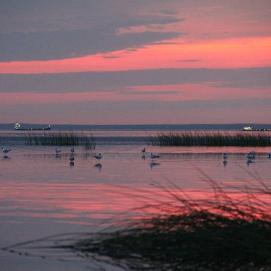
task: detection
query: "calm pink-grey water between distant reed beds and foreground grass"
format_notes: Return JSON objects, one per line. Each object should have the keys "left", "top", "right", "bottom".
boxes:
{"left": 0, "top": 145, "right": 271, "bottom": 271}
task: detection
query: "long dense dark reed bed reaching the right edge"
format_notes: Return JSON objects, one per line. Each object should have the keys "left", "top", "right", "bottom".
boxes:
{"left": 151, "top": 132, "right": 271, "bottom": 147}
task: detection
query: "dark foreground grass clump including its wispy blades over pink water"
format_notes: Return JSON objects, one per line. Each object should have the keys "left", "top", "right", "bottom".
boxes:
{"left": 72, "top": 182, "right": 271, "bottom": 271}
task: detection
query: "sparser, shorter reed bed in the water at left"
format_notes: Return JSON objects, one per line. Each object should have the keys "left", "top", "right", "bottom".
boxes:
{"left": 25, "top": 132, "right": 96, "bottom": 149}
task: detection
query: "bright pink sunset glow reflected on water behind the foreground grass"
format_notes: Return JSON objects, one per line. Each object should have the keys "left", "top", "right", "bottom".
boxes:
{"left": 0, "top": 183, "right": 271, "bottom": 224}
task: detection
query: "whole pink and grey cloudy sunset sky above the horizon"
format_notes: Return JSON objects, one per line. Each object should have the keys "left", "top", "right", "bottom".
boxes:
{"left": 0, "top": 0, "right": 271, "bottom": 124}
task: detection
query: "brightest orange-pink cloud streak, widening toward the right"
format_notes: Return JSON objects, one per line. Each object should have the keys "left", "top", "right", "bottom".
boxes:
{"left": 0, "top": 37, "right": 271, "bottom": 74}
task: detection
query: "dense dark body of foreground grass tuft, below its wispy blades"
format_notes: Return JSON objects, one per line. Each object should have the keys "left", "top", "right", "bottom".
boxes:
{"left": 77, "top": 212, "right": 271, "bottom": 270}
